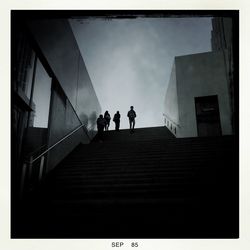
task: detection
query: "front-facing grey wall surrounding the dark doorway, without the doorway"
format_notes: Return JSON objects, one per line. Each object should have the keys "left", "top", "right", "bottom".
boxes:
{"left": 176, "top": 51, "right": 232, "bottom": 137}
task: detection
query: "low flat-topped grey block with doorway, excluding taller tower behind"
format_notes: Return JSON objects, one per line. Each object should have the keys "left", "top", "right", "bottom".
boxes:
{"left": 164, "top": 51, "right": 232, "bottom": 137}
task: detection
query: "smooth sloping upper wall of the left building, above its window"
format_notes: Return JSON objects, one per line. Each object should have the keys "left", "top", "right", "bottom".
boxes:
{"left": 28, "top": 19, "right": 101, "bottom": 135}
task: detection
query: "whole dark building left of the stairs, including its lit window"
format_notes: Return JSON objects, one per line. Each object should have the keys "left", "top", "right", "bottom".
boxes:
{"left": 11, "top": 11, "right": 101, "bottom": 197}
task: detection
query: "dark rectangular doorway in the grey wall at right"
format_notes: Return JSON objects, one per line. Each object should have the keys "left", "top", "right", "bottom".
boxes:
{"left": 195, "top": 95, "right": 221, "bottom": 136}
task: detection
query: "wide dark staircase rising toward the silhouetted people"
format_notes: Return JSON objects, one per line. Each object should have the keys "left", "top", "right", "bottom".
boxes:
{"left": 17, "top": 127, "right": 239, "bottom": 238}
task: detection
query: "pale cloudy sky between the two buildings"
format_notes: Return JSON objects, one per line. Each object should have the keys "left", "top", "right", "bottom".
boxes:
{"left": 70, "top": 18, "right": 212, "bottom": 129}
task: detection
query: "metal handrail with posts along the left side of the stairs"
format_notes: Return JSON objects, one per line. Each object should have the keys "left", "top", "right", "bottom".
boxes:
{"left": 20, "top": 124, "right": 91, "bottom": 198}
